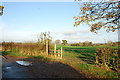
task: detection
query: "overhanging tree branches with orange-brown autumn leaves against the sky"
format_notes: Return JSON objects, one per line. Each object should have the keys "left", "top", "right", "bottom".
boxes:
{"left": 73, "top": 0, "right": 120, "bottom": 33}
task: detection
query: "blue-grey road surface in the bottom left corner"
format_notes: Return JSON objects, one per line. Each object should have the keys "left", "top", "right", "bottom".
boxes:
{"left": 0, "top": 53, "right": 38, "bottom": 78}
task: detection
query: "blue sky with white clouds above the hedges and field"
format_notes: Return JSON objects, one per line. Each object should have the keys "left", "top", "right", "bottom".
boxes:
{"left": 0, "top": 2, "right": 118, "bottom": 43}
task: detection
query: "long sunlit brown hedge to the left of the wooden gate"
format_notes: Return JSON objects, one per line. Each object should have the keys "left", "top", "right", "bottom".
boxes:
{"left": 2, "top": 42, "right": 53, "bottom": 56}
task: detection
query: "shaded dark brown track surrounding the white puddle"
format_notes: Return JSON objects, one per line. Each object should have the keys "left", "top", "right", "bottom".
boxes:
{"left": 2, "top": 56, "right": 84, "bottom": 78}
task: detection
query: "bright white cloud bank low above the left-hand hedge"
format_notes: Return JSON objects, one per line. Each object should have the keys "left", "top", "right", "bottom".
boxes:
{"left": 0, "top": 22, "right": 37, "bottom": 41}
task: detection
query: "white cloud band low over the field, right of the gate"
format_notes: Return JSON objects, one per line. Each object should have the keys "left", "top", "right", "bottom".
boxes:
{"left": 54, "top": 28, "right": 118, "bottom": 43}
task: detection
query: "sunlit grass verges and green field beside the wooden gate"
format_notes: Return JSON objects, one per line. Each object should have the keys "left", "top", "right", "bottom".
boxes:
{"left": 0, "top": 45, "right": 120, "bottom": 78}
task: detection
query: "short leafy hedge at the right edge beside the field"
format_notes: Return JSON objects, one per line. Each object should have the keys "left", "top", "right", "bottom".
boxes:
{"left": 96, "top": 48, "right": 120, "bottom": 71}
